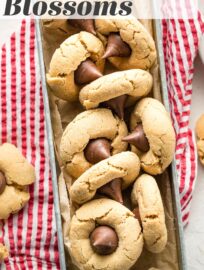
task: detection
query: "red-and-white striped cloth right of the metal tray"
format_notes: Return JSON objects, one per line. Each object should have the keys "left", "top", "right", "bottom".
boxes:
{"left": 162, "top": 11, "right": 204, "bottom": 226}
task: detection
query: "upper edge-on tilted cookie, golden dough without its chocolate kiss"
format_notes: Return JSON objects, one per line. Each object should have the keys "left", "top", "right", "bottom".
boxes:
{"left": 79, "top": 69, "right": 153, "bottom": 109}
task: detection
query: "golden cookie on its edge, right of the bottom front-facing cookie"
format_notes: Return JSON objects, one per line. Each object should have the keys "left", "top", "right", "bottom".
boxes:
{"left": 131, "top": 174, "right": 167, "bottom": 253}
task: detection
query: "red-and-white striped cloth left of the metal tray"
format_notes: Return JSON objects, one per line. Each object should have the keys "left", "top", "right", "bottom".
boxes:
{"left": 0, "top": 19, "right": 60, "bottom": 270}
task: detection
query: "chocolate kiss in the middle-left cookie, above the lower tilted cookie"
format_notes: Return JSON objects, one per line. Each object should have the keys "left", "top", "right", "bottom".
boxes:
{"left": 84, "top": 138, "right": 111, "bottom": 164}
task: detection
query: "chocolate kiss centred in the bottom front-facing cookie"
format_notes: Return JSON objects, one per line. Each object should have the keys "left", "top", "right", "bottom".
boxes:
{"left": 90, "top": 226, "right": 118, "bottom": 255}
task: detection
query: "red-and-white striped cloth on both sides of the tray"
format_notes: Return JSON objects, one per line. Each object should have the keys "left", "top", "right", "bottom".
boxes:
{"left": 0, "top": 16, "right": 204, "bottom": 270}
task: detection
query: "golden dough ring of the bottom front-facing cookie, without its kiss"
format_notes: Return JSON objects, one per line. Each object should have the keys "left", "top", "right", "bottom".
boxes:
{"left": 69, "top": 199, "right": 143, "bottom": 270}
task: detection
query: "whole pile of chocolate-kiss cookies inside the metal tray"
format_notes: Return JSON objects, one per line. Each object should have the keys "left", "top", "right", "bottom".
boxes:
{"left": 47, "top": 18, "right": 175, "bottom": 270}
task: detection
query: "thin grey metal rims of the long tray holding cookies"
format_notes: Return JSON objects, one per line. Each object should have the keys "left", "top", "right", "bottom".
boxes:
{"left": 36, "top": 17, "right": 187, "bottom": 270}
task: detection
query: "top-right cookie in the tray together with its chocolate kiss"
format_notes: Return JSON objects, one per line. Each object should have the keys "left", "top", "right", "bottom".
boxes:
{"left": 95, "top": 18, "right": 156, "bottom": 70}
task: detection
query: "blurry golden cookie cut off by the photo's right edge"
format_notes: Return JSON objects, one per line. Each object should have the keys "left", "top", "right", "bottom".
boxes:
{"left": 195, "top": 114, "right": 204, "bottom": 165}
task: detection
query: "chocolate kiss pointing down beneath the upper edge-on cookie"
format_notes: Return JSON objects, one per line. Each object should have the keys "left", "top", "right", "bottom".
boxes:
{"left": 103, "top": 95, "right": 127, "bottom": 119}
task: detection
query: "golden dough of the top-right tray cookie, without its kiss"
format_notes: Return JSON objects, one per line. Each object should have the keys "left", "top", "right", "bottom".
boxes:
{"left": 95, "top": 18, "right": 156, "bottom": 70}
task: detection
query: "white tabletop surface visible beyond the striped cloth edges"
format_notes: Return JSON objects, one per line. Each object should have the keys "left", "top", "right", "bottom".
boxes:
{"left": 0, "top": 17, "right": 204, "bottom": 270}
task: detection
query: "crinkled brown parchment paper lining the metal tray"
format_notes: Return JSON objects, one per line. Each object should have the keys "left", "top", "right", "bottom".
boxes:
{"left": 42, "top": 20, "right": 179, "bottom": 270}
